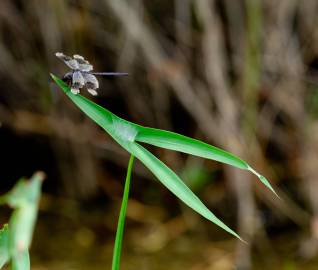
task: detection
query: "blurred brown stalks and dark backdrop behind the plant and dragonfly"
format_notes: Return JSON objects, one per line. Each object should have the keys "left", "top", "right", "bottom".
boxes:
{"left": 0, "top": 0, "right": 318, "bottom": 270}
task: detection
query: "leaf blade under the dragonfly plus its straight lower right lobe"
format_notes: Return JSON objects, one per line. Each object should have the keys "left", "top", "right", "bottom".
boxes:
{"left": 52, "top": 75, "right": 241, "bottom": 239}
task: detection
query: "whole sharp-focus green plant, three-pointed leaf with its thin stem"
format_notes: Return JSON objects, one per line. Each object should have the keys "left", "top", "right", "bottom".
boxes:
{"left": 51, "top": 74, "right": 277, "bottom": 270}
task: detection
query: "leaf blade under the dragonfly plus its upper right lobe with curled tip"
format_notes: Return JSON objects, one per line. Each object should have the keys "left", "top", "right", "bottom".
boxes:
{"left": 51, "top": 74, "right": 278, "bottom": 197}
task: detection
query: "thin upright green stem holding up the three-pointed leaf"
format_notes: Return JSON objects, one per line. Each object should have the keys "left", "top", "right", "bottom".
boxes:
{"left": 112, "top": 155, "right": 135, "bottom": 270}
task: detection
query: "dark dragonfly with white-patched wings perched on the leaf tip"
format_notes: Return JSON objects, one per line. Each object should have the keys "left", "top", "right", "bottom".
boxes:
{"left": 55, "top": 52, "right": 128, "bottom": 96}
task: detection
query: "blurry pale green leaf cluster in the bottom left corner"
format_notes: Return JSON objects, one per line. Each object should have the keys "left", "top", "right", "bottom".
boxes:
{"left": 0, "top": 172, "right": 44, "bottom": 270}
